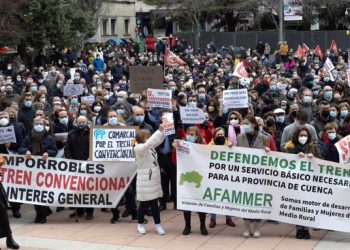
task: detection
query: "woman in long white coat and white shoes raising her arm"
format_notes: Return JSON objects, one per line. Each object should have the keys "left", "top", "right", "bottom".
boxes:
{"left": 134, "top": 124, "right": 165, "bottom": 235}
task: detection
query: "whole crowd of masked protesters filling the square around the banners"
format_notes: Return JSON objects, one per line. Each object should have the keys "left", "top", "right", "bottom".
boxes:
{"left": 0, "top": 36, "right": 350, "bottom": 248}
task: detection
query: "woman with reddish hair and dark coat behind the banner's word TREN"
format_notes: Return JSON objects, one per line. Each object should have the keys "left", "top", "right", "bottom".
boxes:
{"left": 317, "top": 123, "right": 342, "bottom": 162}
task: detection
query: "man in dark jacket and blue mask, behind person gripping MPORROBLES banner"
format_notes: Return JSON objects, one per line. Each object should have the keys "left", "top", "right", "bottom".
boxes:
{"left": 18, "top": 92, "right": 35, "bottom": 131}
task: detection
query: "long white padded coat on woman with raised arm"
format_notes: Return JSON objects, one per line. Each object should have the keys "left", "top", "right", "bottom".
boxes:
{"left": 134, "top": 130, "right": 165, "bottom": 201}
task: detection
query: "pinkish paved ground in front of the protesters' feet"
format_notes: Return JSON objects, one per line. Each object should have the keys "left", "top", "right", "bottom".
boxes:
{"left": 0, "top": 205, "right": 350, "bottom": 250}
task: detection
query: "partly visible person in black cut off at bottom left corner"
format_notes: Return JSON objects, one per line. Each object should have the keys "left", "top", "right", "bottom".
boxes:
{"left": 0, "top": 165, "right": 19, "bottom": 249}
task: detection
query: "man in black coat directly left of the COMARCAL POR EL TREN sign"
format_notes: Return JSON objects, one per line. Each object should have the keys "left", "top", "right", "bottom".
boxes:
{"left": 64, "top": 116, "right": 94, "bottom": 220}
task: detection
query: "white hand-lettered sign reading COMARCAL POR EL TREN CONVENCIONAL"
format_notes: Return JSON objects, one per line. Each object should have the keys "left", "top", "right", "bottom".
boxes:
{"left": 90, "top": 126, "right": 137, "bottom": 161}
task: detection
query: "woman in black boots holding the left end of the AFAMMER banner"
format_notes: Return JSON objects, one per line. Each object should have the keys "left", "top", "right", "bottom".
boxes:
{"left": 172, "top": 126, "right": 208, "bottom": 235}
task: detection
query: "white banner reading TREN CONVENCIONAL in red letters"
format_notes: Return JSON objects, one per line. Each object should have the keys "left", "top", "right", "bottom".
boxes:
{"left": 0, "top": 155, "right": 137, "bottom": 208}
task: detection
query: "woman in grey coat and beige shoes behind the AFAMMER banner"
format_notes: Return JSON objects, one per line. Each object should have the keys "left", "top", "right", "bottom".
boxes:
{"left": 236, "top": 115, "right": 270, "bottom": 238}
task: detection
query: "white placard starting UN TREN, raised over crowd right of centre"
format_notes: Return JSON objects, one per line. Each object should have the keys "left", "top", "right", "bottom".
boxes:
{"left": 223, "top": 89, "right": 249, "bottom": 108}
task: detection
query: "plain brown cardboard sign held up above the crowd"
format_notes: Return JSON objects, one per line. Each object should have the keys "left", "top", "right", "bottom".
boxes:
{"left": 129, "top": 66, "right": 164, "bottom": 93}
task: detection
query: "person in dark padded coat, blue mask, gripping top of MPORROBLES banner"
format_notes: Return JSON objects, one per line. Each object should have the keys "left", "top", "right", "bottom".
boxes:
{"left": 18, "top": 117, "right": 58, "bottom": 224}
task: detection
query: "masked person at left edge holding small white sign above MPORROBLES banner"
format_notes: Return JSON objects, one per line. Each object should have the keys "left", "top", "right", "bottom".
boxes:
{"left": 0, "top": 112, "right": 23, "bottom": 218}
